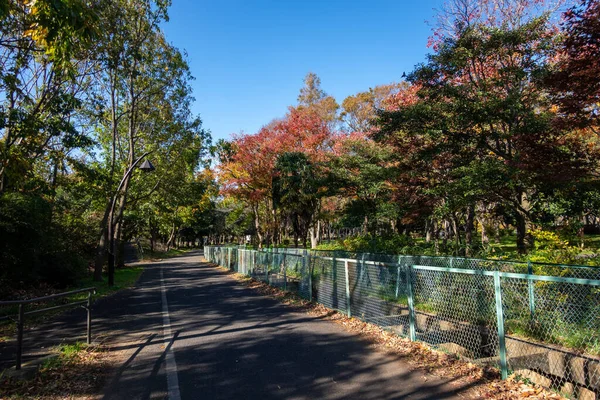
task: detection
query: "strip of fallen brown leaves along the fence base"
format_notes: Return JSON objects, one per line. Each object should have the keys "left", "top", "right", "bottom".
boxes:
{"left": 218, "top": 267, "right": 563, "bottom": 400}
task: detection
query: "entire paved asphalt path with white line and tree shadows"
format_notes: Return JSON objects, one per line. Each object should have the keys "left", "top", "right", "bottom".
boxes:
{"left": 3, "top": 252, "right": 478, "bottom": 400}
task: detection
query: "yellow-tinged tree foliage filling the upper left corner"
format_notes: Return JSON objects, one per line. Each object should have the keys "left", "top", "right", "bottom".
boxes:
{"left": 0, "top": 0, "right": 98, "bottom": 193}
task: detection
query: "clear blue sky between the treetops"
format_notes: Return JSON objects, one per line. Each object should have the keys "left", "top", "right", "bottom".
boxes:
{"left": 163, "top": 0, "right": 442, "bottom": 140}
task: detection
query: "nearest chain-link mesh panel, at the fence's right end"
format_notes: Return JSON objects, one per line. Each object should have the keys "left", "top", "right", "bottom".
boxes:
{"left": 501, "top": 278, "right": 600, "bottom": 399}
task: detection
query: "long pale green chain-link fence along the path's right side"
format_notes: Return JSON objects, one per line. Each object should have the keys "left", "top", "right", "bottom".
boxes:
{"left": 204, "top": 246, "right": 600, "bottom": 399}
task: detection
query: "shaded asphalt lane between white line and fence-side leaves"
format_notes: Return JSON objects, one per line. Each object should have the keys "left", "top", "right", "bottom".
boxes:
{"left": 112, "top": 253, "right": 476, "bottom": 399}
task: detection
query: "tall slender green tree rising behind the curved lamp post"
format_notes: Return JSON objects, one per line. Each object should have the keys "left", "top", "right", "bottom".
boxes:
{"left": 85, "top": 0, "right": 205, "bottom": 279}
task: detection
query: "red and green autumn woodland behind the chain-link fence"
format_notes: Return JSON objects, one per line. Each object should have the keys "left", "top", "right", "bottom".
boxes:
{"left": 211, "top": 0, "right": 600, "bottom": 263}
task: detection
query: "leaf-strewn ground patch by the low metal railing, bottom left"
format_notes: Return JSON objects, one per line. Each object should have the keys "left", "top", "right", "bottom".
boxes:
{"left": 0, "top": 344, "right": 115, "bottom": 400}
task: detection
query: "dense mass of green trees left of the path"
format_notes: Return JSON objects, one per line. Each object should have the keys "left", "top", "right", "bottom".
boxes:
{"left": 0, "top": 0, "right": 216, "bottom": 291}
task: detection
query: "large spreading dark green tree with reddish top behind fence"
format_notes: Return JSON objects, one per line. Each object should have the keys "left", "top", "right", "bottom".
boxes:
{"left": 377, "top": 17, "right": 587, "bottom": 252}
